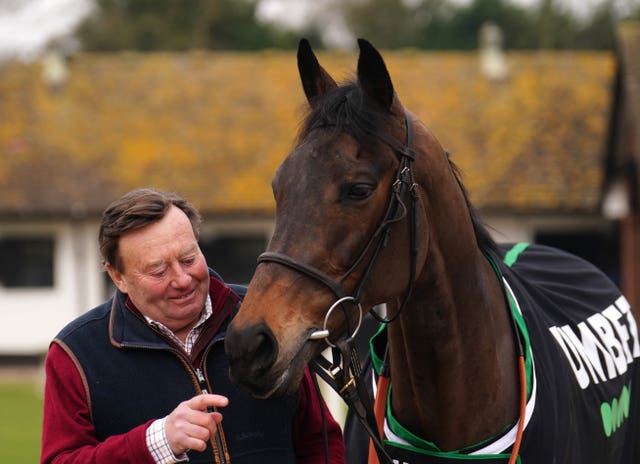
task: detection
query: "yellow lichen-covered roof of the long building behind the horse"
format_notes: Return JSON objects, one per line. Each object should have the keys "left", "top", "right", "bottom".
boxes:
{"left": 0, "top": 50, "right": 614, "bottom": 217}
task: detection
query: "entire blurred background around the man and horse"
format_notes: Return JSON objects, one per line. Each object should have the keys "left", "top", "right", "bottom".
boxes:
{"left": 0, "top": 0, "right": 640, "bottom": 464}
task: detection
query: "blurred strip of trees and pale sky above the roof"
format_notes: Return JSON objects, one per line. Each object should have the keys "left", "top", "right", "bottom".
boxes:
{"left": 0, "top": 0, "right": 639, "bottom": 59}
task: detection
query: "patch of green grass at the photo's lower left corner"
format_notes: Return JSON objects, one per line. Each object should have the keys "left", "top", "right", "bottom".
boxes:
{"left": 0, "top": 380, "right": 42, "bottom": 464}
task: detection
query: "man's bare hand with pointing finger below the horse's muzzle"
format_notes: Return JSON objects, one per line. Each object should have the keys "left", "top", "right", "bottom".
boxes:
{"left": 165, "top": 394, "right": 229, "bottom": 456}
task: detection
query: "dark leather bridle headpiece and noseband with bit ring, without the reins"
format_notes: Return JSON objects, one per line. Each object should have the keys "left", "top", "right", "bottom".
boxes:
{"left": 258, "top": 110, "right": 418, "bottom": 340}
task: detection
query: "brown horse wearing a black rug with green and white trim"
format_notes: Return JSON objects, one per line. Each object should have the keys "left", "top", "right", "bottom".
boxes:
{"left": 225, "top": 39, "right": 640, "bottom": 464}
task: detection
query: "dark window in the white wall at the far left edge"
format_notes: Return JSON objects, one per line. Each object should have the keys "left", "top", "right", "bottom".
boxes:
{"left": 0, "top": 237, "right": 54, "bottom": 288}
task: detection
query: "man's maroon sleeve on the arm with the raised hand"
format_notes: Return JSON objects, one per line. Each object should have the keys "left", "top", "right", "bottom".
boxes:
{"left": 40, "top": 343, "right": 154, "bottom": 464}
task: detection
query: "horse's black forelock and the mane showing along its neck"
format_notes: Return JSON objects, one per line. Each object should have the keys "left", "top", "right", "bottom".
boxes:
{"left": 298, "top": 80, "right": 501, "bottom": 256}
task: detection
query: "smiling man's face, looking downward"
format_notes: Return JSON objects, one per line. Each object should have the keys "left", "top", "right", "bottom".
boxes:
{"left": 107, "top": 206, "right": 209, "bottom": 338}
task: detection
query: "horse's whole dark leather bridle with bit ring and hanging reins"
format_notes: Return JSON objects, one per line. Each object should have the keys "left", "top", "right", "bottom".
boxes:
{"left": 258, "top": 110, "right": 418, "bottom": 463}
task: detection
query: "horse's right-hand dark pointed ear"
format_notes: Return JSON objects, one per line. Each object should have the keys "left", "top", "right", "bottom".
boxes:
{"left": 358, "top": 39, "right": 393, "bottom": 110}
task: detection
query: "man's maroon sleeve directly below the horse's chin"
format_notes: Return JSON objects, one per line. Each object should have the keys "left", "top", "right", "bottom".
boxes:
{"left": 293, "top": 369, "right": 345, "bottom": 464}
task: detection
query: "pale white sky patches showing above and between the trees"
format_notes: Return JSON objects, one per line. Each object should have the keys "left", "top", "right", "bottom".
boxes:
{"left": 0, "top": 0, "right": 636, "bottom": 62}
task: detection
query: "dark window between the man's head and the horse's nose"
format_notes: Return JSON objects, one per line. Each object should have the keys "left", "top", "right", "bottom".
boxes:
{"left": 200, "top": 235, "right": 267, "bottom": 284}
